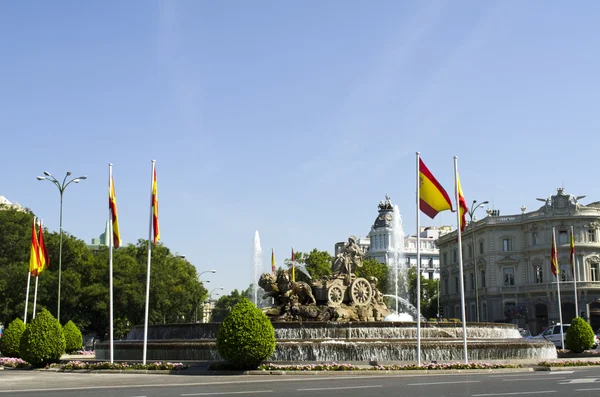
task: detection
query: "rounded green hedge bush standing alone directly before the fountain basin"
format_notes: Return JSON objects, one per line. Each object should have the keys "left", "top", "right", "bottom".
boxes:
{"left": 217, "top": 298, "right": 275, "bottom": 369}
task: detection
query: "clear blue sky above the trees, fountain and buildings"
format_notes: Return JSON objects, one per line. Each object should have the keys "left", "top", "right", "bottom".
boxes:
{"left": 0, "top": 0, "right": 600, "bottom": 292}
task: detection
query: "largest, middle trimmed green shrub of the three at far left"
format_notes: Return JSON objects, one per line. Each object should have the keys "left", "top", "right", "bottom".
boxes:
{"left": 19, "top": 309, "right": 66, "bottom": 367}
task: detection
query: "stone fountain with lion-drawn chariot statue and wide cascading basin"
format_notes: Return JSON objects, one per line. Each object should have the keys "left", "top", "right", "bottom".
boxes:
{"left": 96, "top": 198, "right": 557, "bottom": 363}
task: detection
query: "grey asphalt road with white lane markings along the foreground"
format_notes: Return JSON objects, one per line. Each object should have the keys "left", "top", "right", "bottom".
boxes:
{"left": 0, "top": 367, "right": 600, "bottom": 397}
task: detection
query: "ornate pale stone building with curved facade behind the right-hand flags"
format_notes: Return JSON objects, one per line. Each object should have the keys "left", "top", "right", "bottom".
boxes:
{"left": 437, "top": 189, "right": 600, "bottom": 334}
